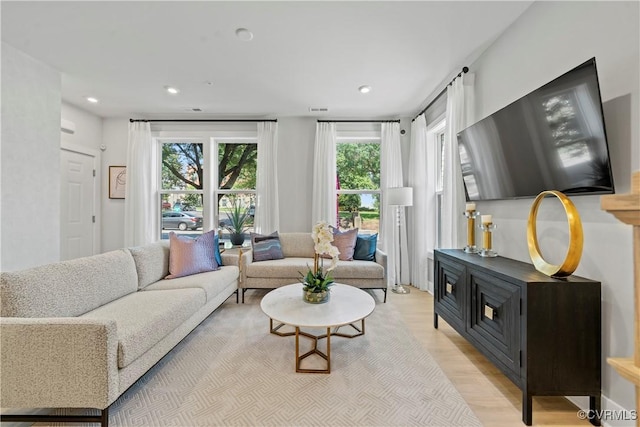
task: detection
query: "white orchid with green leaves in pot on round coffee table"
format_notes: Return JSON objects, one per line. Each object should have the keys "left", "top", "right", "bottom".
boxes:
{"left": 300, "top": 222, "right": 340, "bottom": 304}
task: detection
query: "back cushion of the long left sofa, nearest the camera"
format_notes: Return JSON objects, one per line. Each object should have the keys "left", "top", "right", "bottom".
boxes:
{"left": 0, "top": 249, "right": 138, "bottom": 317}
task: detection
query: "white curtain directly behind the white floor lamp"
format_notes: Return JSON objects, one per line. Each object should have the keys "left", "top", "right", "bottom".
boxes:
{"left": 379, "top": 122, "right": 409, "bottom": 286}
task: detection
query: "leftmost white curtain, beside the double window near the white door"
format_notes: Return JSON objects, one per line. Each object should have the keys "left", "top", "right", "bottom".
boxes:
{"left": 124, "top": 122, "right": 160, "bottom": 247}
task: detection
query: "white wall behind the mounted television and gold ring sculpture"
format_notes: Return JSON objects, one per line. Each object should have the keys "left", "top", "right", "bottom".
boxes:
{"left": 462, "top": 2, "right": 640, "bottom": 410}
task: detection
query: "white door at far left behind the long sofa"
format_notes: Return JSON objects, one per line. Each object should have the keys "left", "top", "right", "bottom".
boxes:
{"left": 60, "top": 149, "right": 95, "bottom": 260}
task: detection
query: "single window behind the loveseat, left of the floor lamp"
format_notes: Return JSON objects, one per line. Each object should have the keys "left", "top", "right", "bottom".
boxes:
{"left": 336, "top": 140, "right": 380, "bottom": 234}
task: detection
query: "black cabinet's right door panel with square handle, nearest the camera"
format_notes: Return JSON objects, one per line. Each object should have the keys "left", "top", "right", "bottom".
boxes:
{"left": 467, "top": 269, "right": 521, "bottom": 375}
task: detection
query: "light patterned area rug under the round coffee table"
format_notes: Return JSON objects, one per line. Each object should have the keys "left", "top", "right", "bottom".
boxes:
{"left": 51, "top": 298, "right": 481, "bottom": 426}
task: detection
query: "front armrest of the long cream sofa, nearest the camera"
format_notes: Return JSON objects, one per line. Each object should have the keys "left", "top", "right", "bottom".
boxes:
{"left": 0, "top": 317, "right": 119, "bottom": 409}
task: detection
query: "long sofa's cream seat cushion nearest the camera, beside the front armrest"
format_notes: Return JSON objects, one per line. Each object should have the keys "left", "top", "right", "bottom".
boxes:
{"left": 81, "top": 288, "right": 206, "bottom": 368}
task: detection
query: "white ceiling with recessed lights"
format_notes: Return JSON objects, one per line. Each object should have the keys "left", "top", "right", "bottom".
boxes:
{"left": 0, "top": 1, "right": 532, "bottom": 119}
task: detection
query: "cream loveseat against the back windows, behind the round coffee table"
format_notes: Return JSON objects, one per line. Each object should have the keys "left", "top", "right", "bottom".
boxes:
{"left": 240, "top": 233, "right": 387, "bottom": 302}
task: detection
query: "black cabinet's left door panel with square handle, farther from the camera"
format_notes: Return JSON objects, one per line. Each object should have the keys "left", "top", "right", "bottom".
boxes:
{"left": 435, "top": 258, "right": 466, "bottom": 330}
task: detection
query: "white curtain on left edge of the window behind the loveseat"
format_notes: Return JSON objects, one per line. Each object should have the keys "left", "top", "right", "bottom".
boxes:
{"left": 311, "top": 122, "right": 338, "bottom": 226}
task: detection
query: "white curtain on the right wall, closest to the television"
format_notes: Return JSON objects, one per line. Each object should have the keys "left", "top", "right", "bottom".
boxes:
{"left": 442, "top": 73, "right": 474, "bottom": 248}
